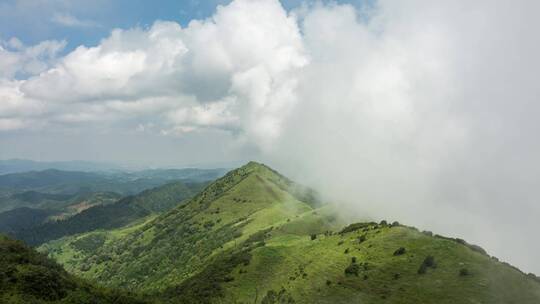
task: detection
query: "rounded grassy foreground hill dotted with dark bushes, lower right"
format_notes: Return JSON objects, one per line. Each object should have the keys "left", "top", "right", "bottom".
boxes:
{"left": 213, "top": 225, "right": 540, "bottom": 303}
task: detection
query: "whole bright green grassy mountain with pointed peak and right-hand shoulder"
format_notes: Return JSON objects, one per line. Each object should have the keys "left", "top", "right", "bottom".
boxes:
{"left": 40, "top": 162, "right": 540, "bottom": 304}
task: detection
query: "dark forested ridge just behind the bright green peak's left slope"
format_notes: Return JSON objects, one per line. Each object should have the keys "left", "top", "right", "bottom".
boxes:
{"left": 11, "top": 182, "right": 209, "bottom": 245}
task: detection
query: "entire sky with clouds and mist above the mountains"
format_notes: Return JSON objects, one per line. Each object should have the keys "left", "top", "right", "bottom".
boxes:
{"left": 0, "top": 0, "right": 540, "bottom": 273}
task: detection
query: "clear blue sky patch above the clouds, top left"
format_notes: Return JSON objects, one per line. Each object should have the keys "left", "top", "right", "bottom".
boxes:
{"left": 0, "top": 0, "right": 369, "bottom": 52}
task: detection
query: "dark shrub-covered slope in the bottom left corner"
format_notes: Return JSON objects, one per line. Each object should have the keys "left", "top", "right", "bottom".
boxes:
{"left": 0, "top": 235, "right": 148, "bottom": 304}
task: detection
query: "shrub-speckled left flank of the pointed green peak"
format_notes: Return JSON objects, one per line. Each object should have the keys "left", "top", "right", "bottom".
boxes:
{"left": 44, "top": 163, "right": 324, "bottom": 291}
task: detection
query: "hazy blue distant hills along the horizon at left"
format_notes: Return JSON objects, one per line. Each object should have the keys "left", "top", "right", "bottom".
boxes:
{"left": 0, "top": 168, "right": 225, "bottom": 212}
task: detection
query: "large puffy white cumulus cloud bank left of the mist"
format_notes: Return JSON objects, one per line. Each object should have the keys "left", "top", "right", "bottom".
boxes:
{"left": 4, "top": 0, "right": 307, "bottom": 144}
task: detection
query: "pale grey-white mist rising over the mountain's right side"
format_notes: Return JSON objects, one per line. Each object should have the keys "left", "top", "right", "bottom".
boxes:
{"left": 265, "top": 1, "right": 540, "bottom": 273}
